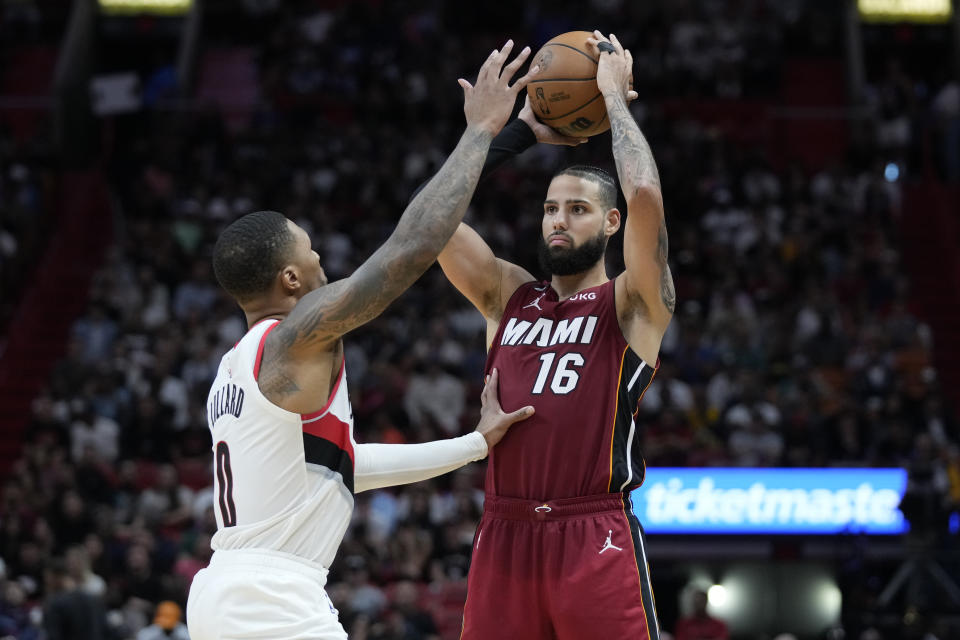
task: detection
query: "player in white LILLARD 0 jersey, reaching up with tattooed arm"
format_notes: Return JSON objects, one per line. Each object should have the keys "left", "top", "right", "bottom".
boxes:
{"left": 187, "top": 41, "right": 537, "bottom": 640}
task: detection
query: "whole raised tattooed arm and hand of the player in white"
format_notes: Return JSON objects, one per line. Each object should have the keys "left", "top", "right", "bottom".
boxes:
{"left": 271, "top": 41, "right": 537, "bottom": 355}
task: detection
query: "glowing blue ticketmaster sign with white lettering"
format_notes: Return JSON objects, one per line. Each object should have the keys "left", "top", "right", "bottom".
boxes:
{"left": 633, "top": 468, "right": 909, "bottom": 534}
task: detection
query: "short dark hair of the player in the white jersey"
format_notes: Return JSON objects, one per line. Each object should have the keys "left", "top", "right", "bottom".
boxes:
{"left": 213, "top": 211, "right": 293, "bottom": 302}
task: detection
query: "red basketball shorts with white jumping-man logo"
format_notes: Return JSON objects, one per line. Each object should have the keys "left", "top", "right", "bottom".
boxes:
{"left": 461, "top": 494, "right": 660, "bottom": 640}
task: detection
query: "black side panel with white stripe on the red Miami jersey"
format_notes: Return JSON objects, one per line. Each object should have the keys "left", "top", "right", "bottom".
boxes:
{"left": 607, "top": 346, "right": 657, "bottom": 493}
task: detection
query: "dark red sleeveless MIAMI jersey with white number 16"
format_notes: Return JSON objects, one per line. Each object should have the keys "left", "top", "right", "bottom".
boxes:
{"left": 486, "top": 280, "right": 656, "bottom": 500}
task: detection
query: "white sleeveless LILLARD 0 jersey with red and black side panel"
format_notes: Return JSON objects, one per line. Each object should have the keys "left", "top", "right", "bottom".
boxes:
{"left": 207, "top": 320, "right": 355, "bottom": 568}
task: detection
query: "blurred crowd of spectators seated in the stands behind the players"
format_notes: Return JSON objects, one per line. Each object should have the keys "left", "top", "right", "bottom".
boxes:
{"left": 0, "top": 0, "right": 960, "bottom": 640}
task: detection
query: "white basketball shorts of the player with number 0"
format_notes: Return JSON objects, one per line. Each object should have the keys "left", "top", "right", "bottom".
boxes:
{"left": 187, "top": 549, "right": 347, "bottom": 640}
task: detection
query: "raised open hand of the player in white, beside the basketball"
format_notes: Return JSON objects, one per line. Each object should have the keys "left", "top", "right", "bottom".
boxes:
{"left": 457, "top": 40, "right": 540, "bottom": 136}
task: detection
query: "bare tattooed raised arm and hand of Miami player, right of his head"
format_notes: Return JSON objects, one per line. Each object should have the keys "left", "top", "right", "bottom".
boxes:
{"left": 588, "top": 31, "right": 676, "bottom": 336}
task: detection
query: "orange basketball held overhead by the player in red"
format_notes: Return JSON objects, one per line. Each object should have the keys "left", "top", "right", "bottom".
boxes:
{"left": 527, "top": 31, "right": 610, "bottom": 138}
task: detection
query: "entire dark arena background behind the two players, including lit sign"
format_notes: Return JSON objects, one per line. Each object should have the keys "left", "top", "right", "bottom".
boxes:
{"left": 0, "top": 0, "right": 960, "bottom": 640}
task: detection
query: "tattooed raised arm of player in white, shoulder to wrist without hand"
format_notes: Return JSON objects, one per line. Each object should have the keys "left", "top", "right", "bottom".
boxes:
{"left": 277, "top": 127, "right": 492, "bottom": 348}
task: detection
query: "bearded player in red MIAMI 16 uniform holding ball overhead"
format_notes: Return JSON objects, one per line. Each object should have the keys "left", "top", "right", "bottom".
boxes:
{"left": 440, "top": 32, "right": 675, "bottom": 640}
